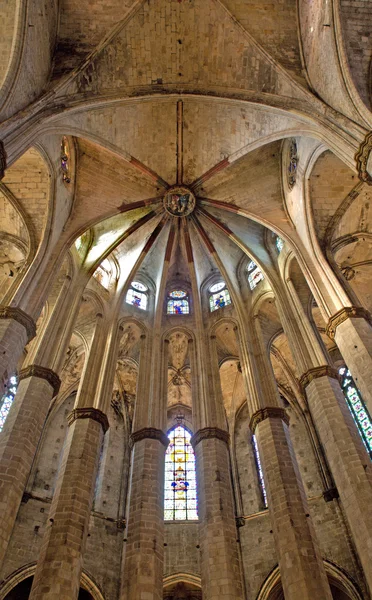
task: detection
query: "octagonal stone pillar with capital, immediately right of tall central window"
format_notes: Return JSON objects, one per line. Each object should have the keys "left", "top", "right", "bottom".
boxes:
{"left": 191, "top": 428, "right": 244, "bottom": 600}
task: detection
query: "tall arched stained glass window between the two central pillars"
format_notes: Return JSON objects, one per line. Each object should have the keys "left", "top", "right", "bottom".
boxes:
{"left": 164, "top": 425, "right": 198, "bottom": 521}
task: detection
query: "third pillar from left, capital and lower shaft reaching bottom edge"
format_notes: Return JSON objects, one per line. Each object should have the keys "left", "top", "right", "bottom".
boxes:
{"left": 30, "top": 408, "right": 103, "bottom": 600}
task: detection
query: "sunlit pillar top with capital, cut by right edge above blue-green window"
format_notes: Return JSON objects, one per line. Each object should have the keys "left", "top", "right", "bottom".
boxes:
{"left": 327, "top": 306, "right": 372, "bottom": 415}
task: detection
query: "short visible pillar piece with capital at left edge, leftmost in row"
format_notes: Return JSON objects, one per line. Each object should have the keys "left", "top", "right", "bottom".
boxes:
{"left": 0, "top": 306, "right": 36, "bottom": 397}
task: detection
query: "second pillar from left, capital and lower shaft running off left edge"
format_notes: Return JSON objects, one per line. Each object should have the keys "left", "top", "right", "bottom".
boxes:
{"left": 0, "top": 365, "right": 59, "bottom": 564}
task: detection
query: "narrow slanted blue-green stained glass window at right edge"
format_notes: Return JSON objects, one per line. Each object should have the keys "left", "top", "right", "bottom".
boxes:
{"left": 338, "top": 367, "right": 372, "bottom": 456}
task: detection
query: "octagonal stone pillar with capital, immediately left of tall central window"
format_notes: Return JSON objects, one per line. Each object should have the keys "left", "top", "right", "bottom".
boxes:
{"left": 120, "top": 428, "right": 169, "bottom": 600}
